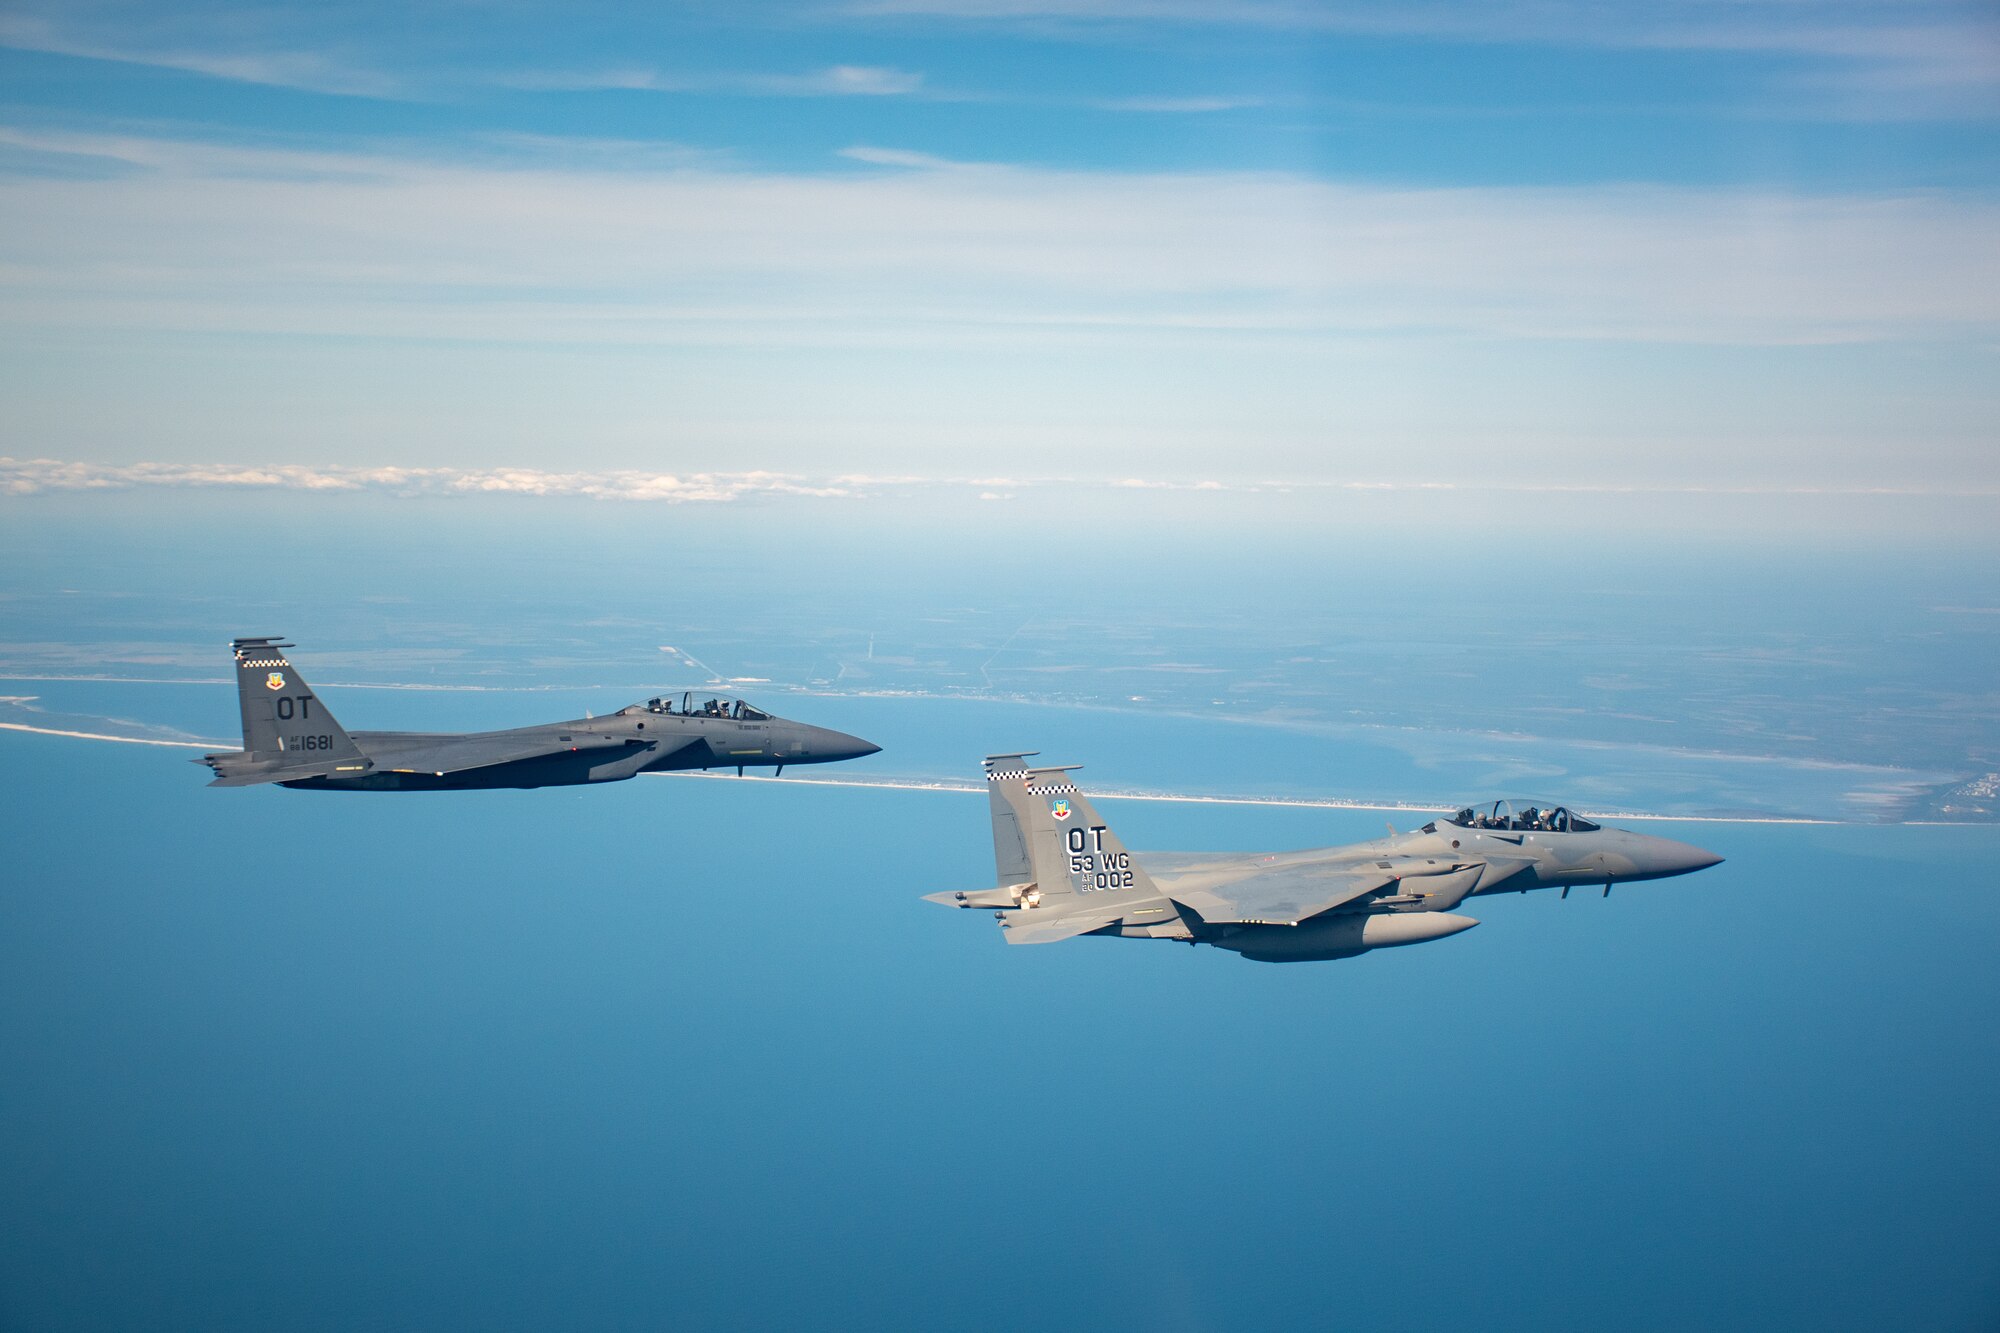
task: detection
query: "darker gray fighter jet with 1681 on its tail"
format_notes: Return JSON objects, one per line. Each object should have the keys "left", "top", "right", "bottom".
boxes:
{"left": 196, "top": 638, "right": 882, "bottom": 791}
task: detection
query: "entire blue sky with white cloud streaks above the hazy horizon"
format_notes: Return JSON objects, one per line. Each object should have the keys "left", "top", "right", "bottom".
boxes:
{"left": 0, "top": 0, "right": 2000, "bottom": 500}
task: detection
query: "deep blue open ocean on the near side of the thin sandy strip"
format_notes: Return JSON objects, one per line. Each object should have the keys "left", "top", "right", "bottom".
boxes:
{"left": 0, "top": 735, "right": 2000, "bottom": 1329}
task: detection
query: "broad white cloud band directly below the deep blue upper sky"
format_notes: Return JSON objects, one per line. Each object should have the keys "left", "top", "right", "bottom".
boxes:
{"left": 0, "top": 128, "right": 2000, "bottom": 346}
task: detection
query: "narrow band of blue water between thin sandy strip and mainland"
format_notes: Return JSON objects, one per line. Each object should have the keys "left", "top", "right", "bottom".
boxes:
{"left": 0, "top": 680, "right": 1936, "bottom": 819}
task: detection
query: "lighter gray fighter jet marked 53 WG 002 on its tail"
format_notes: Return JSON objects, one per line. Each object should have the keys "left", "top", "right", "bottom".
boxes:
{"left": 926, "top": 751, "right": 1722, "bottom": 963}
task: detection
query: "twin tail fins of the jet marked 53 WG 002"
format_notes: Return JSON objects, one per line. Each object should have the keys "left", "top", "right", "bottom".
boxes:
{"left": 986, "top": 755, "right": 1158, "bottom": 899}
